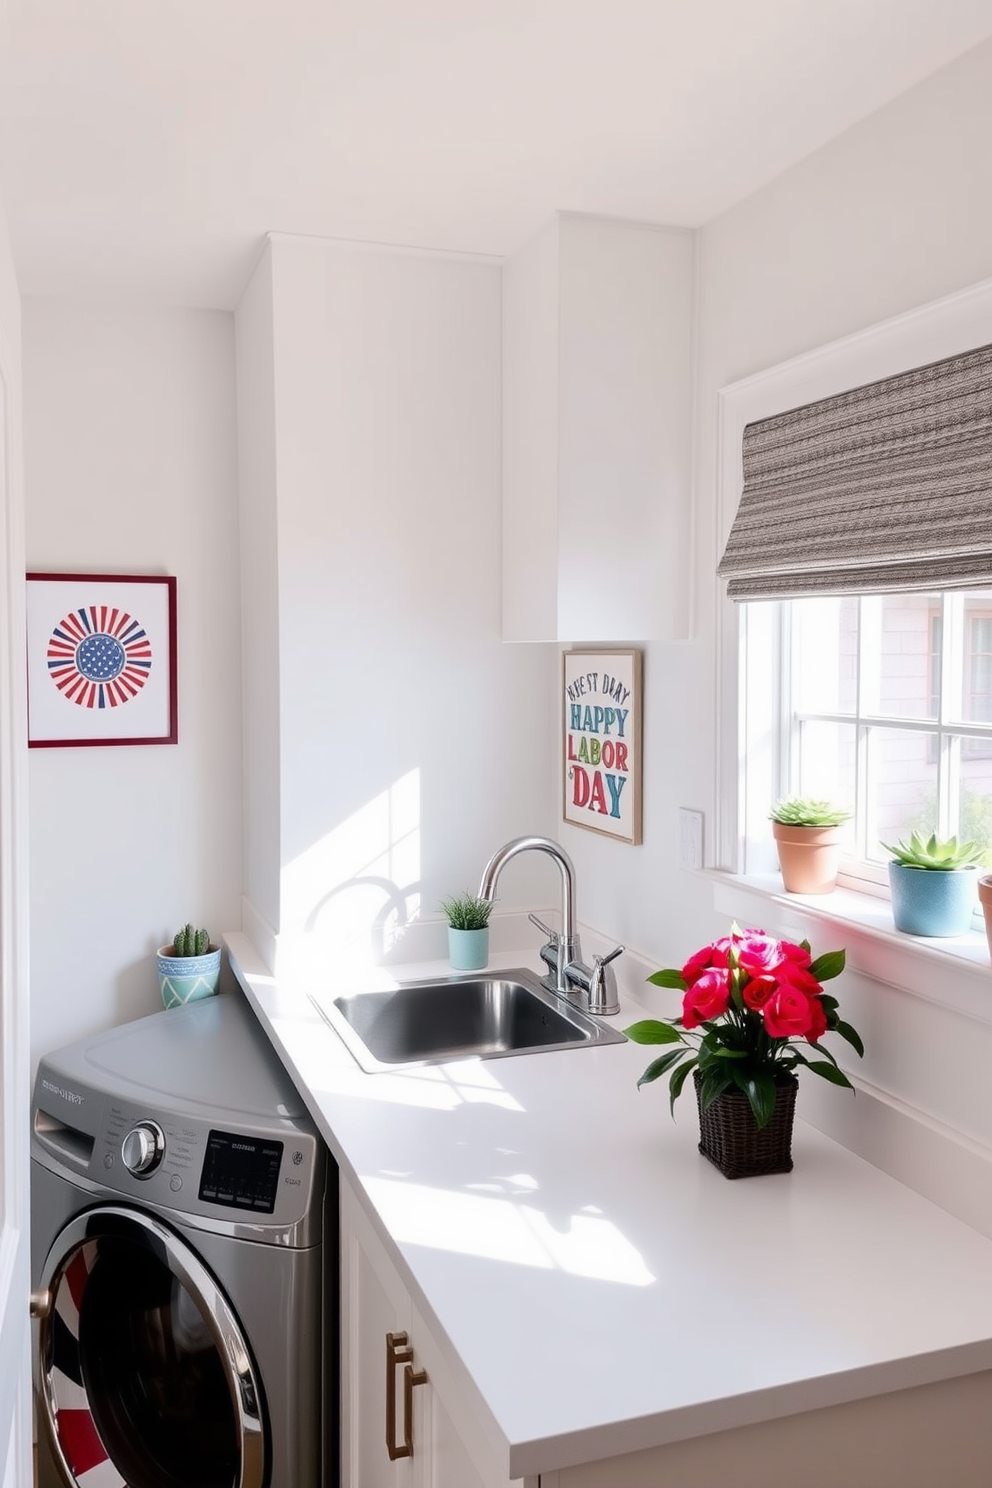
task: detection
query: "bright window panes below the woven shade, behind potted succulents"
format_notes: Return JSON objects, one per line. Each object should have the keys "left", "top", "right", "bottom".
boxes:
{"left": 744, "top": 591, "right": 992, "bottom": 885}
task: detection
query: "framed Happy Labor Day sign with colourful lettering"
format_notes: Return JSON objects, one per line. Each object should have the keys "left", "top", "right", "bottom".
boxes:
{"left": 562, "top": 650, "right": 642, "bottom": 844}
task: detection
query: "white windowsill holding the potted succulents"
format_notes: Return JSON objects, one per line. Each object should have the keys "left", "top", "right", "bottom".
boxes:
{"left": 705, "top": 869, "right": 992, "bottom": 1024}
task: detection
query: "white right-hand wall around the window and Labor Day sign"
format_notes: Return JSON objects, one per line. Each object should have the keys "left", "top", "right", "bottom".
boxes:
{"left": 562, "top": 34, "right": 992, "bottom": 964}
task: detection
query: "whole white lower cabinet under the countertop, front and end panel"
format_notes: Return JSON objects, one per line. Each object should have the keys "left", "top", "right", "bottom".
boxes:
{"left": 341, "top": 1181, "right": 992, "bottom": 1488}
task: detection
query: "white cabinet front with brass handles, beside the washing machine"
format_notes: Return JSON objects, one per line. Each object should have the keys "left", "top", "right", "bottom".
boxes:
{"left": 341, "top": 1180, "right": 537, "bottom": 1488}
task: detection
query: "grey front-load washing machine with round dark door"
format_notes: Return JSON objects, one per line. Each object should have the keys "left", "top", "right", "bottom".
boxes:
{"left": 31, "top": 992, "right": 338, "bottom": 1488}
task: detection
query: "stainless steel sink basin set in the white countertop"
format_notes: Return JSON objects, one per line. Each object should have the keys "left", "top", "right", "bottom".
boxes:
{"left": 312, "top": 969, "right": 625, "bottom": 1073}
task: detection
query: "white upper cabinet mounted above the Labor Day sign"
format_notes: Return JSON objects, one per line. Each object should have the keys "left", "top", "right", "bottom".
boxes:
{"left": 503, "top": 214, "right": 693, "bottom": 643}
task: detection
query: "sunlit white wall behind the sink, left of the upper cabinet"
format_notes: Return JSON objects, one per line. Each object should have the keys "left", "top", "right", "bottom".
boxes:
{"left": 238, "top": 238, "right": 558, "bottom": 958}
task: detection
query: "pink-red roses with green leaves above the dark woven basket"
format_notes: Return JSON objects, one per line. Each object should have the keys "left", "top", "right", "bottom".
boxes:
{"left": 625, "top": 926, "right": 864, "bottom": 1126}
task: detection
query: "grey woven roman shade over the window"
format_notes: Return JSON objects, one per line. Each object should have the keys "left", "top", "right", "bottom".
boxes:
{"left": 717, "top": 347, "right": 992, "bottom": 600}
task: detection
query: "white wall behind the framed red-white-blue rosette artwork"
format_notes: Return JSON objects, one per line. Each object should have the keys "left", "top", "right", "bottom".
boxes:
{"left": 24, "top": 299, "right": 241, "bottom": 1058}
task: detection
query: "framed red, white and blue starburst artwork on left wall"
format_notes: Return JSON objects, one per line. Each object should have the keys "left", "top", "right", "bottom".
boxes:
{"left": 27, "top": 573, "right": 178, "bottom": 748}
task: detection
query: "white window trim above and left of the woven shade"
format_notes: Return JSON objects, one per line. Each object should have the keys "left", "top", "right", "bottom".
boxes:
{"left": 714, "top": 270, "right": 992, "bottom": 873}
